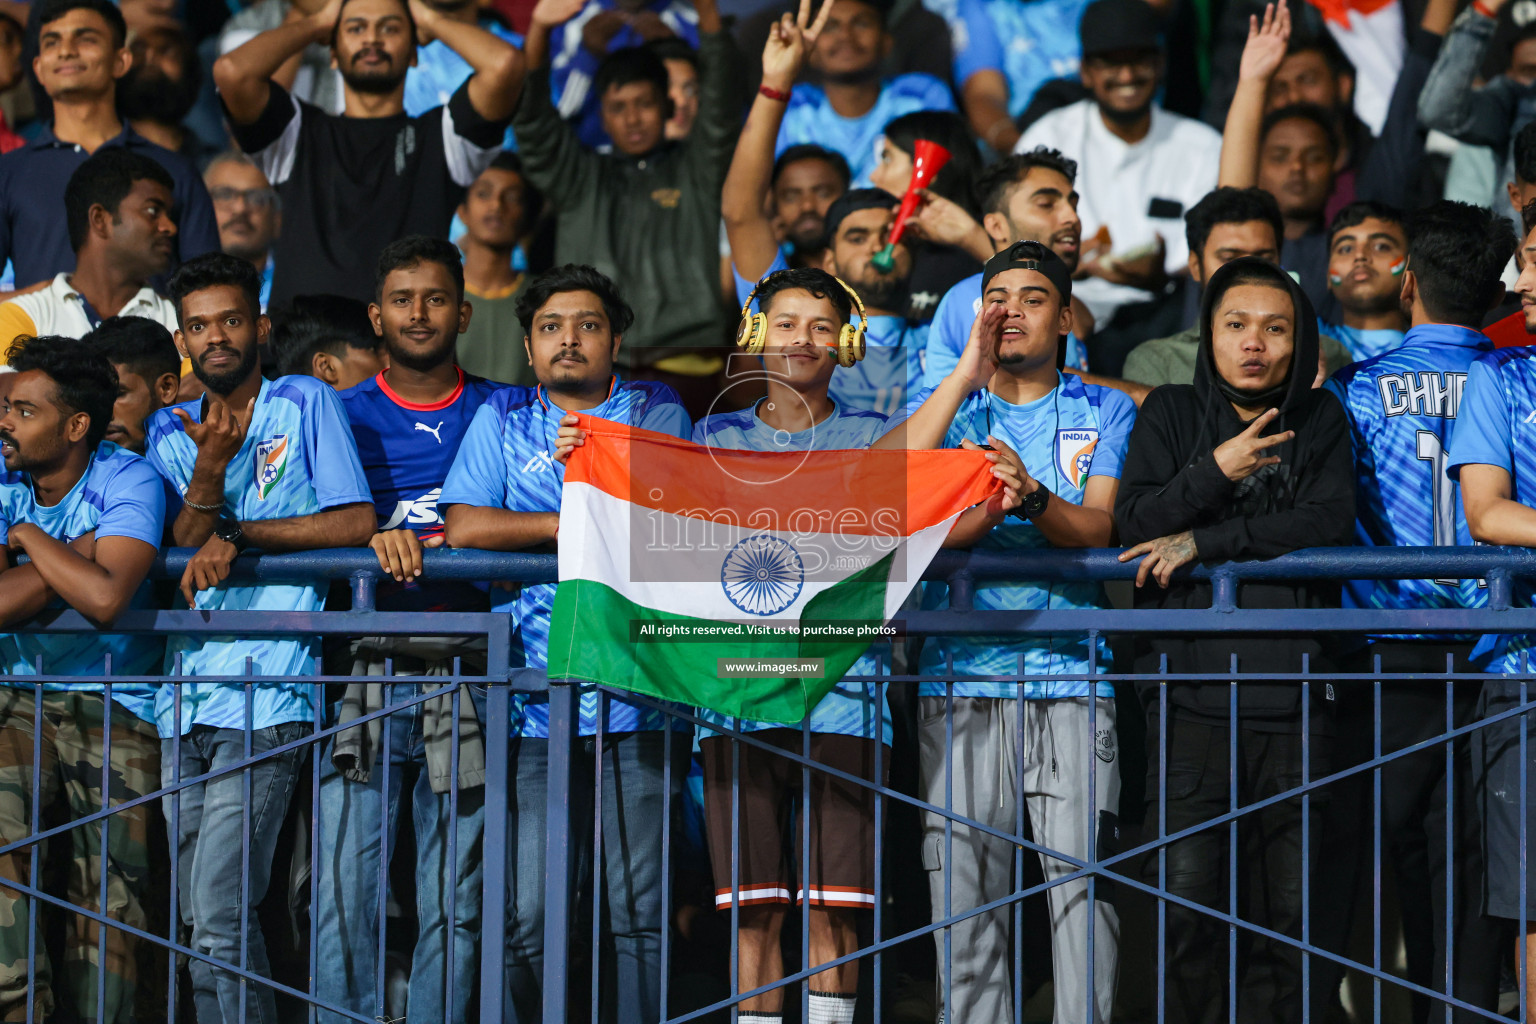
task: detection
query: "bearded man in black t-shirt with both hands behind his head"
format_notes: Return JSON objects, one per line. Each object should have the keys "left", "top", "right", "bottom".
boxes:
{"left": 214, "top": 0, "right": 522, "bottom": 309}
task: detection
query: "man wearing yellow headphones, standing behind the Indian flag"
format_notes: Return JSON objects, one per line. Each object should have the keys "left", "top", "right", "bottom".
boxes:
{"left": 688, "top": 267, "right": 1021, "bottom": 1024}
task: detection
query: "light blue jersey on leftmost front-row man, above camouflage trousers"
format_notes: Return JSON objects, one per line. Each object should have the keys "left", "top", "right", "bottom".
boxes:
{"left": 0, "top": 441, "right": 166, "bottom": 722}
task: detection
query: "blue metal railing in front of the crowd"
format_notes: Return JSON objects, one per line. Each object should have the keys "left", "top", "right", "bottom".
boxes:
{"left": 0, "top": 547, "right": 1536, "bottom": 1022}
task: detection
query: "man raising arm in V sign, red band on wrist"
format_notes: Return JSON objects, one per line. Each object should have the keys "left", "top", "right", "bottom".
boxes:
{"left": 720, "top": 2, "right": 851, "bottom": 288}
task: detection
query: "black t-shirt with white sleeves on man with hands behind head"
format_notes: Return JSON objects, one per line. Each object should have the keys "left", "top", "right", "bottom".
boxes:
{"left": 235, "top": 81, "right": 507, "bottom": 309}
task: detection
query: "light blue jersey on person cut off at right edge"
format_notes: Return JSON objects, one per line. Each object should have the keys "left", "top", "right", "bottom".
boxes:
{"left": 1443, "top": 347, "right": 1536, "bottom": 672}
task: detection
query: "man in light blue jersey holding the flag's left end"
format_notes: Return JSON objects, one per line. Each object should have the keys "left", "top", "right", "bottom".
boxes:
{"left": 438, "top": 266, "right": 693, "bottom": 1024}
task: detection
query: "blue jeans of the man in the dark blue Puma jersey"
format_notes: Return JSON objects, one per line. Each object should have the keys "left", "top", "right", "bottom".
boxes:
{"left": 315, "top": 683, "right": 485, "bottom": 1024}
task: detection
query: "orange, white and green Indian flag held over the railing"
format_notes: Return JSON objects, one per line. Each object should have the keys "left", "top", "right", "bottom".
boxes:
{"left": 548, "top": 416, "right": 1000, "bottom": 723}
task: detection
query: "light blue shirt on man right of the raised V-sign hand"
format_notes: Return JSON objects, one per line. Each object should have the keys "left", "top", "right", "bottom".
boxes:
{"left": 774, "top": 72, "right": 955, "bottom": 189}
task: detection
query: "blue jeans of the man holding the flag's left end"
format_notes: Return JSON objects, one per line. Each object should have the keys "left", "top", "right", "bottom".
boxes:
{"left": 505, "top": 732, "right": 690, "bottom": 1024}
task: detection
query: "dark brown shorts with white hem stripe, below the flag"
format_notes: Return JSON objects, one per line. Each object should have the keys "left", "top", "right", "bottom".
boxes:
{"left": 699, "top": 729, "right": 891, "bottom": 910}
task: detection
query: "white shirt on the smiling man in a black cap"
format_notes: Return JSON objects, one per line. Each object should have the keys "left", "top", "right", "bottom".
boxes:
{"left": 1014, "top": 98, "right": 1221, "bottom": 322}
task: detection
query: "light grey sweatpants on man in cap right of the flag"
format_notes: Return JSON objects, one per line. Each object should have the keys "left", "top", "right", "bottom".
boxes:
{"left": 919, "top": 697, "right": 1120, "bottom": 1024}
